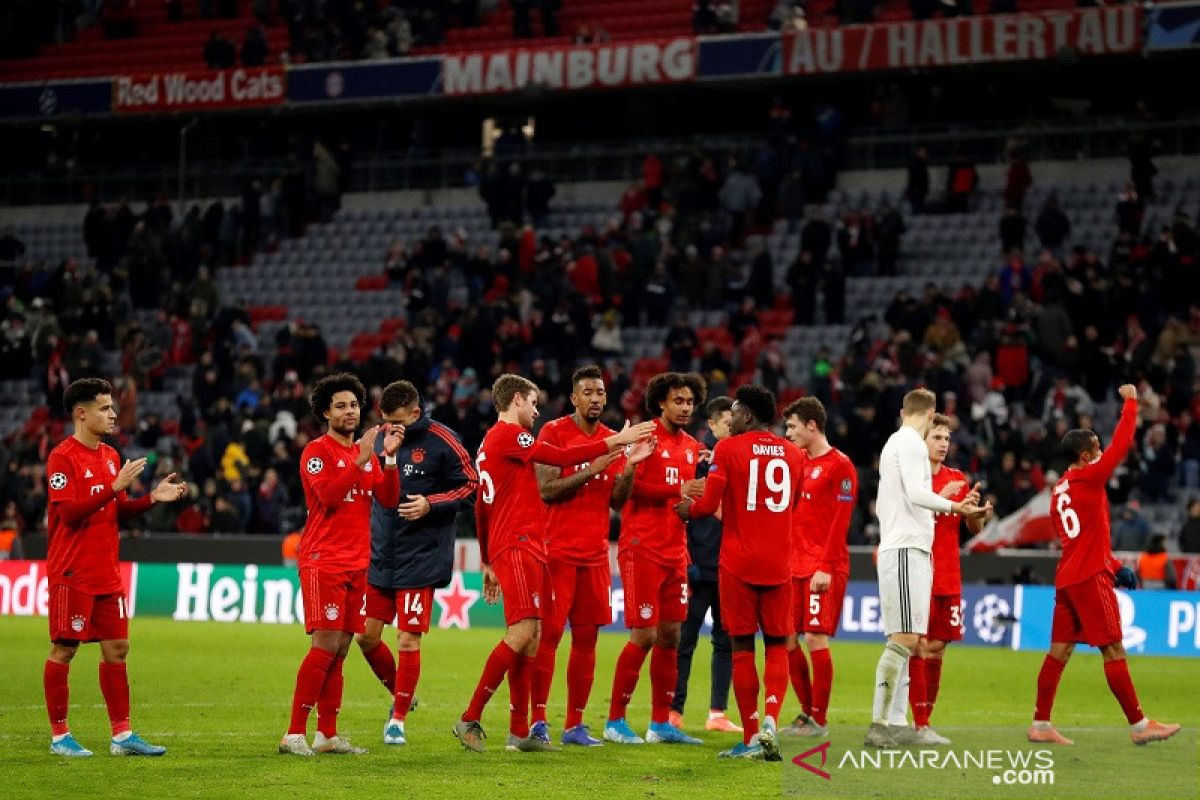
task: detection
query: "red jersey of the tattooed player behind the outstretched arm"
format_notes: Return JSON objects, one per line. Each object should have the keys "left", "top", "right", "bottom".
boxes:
{"left": 538, "top": 415, "right": 625, "bottom": 566}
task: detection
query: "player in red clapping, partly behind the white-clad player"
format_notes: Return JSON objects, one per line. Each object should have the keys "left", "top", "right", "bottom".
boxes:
{"left": 908, "top": 414, "right": 985, "bottom": 745}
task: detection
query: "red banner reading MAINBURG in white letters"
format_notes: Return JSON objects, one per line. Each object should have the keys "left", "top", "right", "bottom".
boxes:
{"left": 442, "top": 36, "right": 696, "bottom": 96}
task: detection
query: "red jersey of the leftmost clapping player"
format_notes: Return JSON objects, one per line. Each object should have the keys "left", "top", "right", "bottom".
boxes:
{"left": 46, "top": 437, "right": 152, "bottom": 595}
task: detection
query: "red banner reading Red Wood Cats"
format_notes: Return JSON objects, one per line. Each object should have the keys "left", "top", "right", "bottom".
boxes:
{"left": 113, "top": 67, "right": 288, "bottom": 114}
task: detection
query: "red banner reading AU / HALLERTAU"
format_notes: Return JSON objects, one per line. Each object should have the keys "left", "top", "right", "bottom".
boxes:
{"left": 782, "top": 5, "right": 1142, "bottom": 76}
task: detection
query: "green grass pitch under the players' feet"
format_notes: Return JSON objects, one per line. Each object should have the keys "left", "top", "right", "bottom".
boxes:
{"left": 0, "top": 618, "right": 1200, "bottom": 800}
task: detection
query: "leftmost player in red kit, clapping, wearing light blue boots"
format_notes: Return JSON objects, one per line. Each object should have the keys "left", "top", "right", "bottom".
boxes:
{"left": 42, "top": 378, "right": 187, "bottom": 757}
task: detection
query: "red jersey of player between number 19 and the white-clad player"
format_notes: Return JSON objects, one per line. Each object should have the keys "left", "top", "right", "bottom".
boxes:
{"left": 791, "top": 447, "right": 858, "bottom": 578}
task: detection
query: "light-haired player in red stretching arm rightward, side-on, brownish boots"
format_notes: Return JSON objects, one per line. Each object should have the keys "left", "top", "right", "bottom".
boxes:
{"left": 454, "top": 374, "right": 654, "bottom": 752}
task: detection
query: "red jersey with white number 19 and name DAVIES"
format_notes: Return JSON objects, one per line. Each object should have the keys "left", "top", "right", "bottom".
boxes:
{"left": 690, "top": 431, "right": 804, "bottom": 587}
